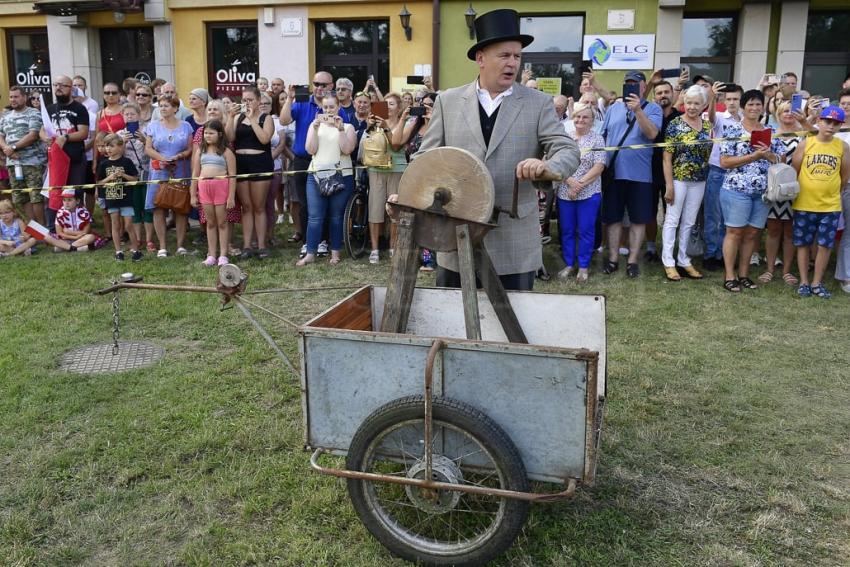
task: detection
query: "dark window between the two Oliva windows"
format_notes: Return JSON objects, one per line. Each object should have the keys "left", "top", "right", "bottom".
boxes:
{"left": 100, "top": 27, "right": 156, "bottom": 86}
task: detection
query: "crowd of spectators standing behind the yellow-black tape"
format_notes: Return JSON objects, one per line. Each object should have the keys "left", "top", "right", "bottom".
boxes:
{"left": 0, "top": 71, "right": 850, "bottom": 297}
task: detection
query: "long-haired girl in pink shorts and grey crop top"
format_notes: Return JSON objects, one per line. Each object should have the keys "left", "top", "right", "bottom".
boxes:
{"left": 190, "top": 120, "right": 236, "bottom": 266}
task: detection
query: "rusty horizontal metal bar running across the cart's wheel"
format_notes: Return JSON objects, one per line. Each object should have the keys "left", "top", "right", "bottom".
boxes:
{"left": 310, "top": 447, "right": 577, "bottom": 502}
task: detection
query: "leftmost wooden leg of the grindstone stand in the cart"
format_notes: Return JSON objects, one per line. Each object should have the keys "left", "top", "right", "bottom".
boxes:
{"left": 381, "top": 211, "right": 419, "bottom": 333}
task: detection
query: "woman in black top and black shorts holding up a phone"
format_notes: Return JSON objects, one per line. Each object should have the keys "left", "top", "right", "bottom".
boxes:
{"left": 225, "top": 86, "right": 274, "bottom": 260}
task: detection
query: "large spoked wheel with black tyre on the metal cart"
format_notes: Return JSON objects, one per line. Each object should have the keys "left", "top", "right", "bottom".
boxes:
{"left": 346, "top": 396, "right": 528, "bottom": 565}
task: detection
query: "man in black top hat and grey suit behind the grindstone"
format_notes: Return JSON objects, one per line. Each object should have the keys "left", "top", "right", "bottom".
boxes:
{"left": 417, "top": 10, "right": 580, "bottom": 290}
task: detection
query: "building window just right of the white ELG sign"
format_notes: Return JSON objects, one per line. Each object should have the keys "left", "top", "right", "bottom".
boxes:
{"left": 680, "top": 14, "right": 738, "bottom": 82}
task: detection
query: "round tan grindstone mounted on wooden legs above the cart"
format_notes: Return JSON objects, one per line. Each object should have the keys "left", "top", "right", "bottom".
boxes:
{"left": 398, "top": 147, "right": 496, "bottom": 225}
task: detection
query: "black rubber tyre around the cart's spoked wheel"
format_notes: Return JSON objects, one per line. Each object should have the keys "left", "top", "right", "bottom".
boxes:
{"left": 346, "top": 395, "right": 529, "bottom": 567}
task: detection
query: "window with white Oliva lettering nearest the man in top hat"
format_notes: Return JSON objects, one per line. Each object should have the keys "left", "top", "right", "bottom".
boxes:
{"left": 207, "top": 21, "right": 260, "bottom": 98}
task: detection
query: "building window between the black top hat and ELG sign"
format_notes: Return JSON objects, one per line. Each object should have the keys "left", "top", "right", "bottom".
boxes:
{"left": 517, "top": 15, "right": 584, "bottom": 96}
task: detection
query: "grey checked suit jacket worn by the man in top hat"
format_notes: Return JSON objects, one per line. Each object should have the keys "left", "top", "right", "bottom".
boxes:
{"left": 414, "top": 81, "right": 581, "bottom": 275}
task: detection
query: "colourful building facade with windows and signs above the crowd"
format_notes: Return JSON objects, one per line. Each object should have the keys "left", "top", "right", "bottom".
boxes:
{"left": 0, "top": 0, "right": 850, "bottom": 103}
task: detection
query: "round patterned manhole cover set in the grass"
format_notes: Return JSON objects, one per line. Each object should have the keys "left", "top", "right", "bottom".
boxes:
{"left": 59, "top": 341, "right": 165, "bottom": 374}
